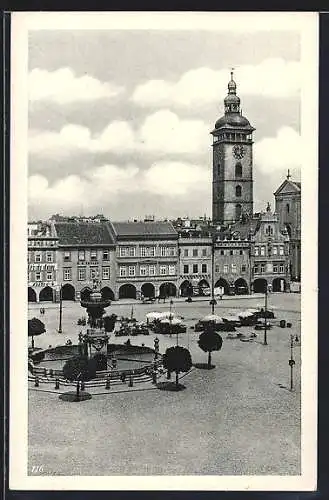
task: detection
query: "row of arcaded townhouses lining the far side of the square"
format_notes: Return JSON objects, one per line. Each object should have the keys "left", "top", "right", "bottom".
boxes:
{"left": 28, "top": 174, "right": 300, "bottom": 302}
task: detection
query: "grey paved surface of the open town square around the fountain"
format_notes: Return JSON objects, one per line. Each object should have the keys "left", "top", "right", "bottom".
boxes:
{"left": 28, "top": 294, "right": 302, "bottom": 476}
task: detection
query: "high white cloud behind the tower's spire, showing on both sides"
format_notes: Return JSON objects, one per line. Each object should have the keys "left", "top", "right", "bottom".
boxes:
{"left": 131, "top": 58, "right": 301, "bottom": 107}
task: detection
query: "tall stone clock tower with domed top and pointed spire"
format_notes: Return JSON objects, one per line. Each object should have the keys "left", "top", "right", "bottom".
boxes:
{"left": 211, "top": 71, "right": 255, "bottom": 225}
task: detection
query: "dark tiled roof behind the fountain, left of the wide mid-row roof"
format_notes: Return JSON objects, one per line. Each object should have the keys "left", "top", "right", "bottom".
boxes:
{"left": 55, "top": 222, "right": 114, "bottom": 246}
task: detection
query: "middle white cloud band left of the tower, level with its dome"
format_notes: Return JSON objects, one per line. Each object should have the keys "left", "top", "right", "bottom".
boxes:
{"left": 29, "top": 110, "right": 209, "bottom": 157}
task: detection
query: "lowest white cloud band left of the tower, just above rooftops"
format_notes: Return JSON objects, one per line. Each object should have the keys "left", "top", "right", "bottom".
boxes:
{"left": 29, "top": 161, "right": 211, "bottom": 215}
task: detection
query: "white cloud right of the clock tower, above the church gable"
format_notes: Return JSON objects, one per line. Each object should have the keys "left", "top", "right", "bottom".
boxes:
{"left": 254, "top": 127, "right": 303, "bottom": 173}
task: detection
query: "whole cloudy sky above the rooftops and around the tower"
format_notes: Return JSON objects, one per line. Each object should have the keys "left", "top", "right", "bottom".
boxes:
{"left": 28, "top": 22, "right": 301, "bottom": 220}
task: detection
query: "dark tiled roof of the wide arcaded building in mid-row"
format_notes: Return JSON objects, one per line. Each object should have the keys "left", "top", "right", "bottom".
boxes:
{"left": 112, "top": 222, "right": 178, "bottom": 239}
